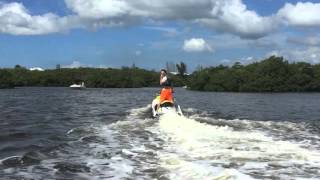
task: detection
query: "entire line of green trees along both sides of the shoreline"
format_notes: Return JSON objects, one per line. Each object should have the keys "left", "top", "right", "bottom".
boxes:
{"left": 0, "top": 56, "right": 320, "bottom": 92}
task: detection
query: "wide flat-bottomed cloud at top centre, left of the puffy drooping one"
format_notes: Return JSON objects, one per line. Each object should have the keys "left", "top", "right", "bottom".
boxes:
{"left": 65, "top": 0, "right": 212, "bottom": 20}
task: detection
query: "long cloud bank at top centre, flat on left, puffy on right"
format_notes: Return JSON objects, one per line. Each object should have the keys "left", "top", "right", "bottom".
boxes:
{"left": 65, "top": 0, "right": 276, "bottom": 38}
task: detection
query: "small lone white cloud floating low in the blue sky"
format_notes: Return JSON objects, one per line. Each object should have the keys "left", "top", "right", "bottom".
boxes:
{"left": 182, "top": 38, "right": 213, "bottom": 52}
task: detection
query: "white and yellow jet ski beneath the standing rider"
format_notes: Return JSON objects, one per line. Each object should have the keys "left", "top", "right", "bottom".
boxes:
{"left": 151, "top": 96, "right": 183, "bottom": 118}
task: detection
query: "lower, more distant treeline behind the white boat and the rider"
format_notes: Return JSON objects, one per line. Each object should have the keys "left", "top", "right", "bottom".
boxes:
{"left": 0, "top": 65, "right": 186, "bottom": 88}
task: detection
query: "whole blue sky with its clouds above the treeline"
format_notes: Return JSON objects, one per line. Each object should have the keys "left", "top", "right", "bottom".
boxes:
{"left": 0, "top": 0, "right": 320, "bottom": 71}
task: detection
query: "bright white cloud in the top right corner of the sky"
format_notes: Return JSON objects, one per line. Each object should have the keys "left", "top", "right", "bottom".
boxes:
{"left": 277, "top": 2, "right": 320, "bottom": 26}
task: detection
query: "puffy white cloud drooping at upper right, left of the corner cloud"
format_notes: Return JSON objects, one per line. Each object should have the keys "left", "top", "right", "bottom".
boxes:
{"left": 197, "top": 0, "right": 278, "bottom": 39}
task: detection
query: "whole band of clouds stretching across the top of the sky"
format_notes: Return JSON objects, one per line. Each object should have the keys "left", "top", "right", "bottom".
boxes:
{"left": 0, "top": 0, "right": 320, "bottom": 39}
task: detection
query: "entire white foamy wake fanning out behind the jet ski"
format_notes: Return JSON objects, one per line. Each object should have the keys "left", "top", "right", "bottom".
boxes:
{"left": 42, "top": 106, "right": 320, "bottom": 180}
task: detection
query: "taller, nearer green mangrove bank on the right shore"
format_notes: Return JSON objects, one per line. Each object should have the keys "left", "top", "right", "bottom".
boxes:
{"left": 188, "top": 56, "right": 320, "bottom": 92}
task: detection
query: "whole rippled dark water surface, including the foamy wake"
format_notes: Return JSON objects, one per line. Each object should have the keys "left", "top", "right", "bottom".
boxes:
{"left": 0, "top": 88, "right": 320, "bottom": 179}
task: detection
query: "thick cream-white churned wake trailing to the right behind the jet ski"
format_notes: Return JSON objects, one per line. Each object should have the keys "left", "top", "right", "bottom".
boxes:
{"left": 154, "top": 113, "right": 320, "bottom": 179}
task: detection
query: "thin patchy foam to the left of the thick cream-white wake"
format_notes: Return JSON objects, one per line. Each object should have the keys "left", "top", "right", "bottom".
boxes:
{"left": 76, "top": 106, "right": 159, "bottom": 179}
